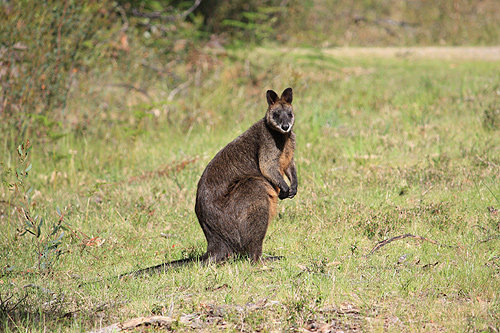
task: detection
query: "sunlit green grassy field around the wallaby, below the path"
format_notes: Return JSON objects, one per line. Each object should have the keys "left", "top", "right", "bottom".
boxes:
{"left": 0, "top": 47, "right": 500, "bottom": 332}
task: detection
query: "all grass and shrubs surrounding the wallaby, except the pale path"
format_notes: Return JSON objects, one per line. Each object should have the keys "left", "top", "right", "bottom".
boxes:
{"left": 0, "top": 0, "right": 500, "bottom": 331}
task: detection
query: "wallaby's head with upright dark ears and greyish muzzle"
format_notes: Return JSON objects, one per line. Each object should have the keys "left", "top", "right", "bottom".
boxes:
{"left": 266, "top": 88, "right": 295, "bottom": 133}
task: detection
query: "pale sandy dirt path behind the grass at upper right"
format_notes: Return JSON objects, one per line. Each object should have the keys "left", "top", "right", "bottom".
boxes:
{"left": 323, "top": 46, "right": 500, "bottom": 61}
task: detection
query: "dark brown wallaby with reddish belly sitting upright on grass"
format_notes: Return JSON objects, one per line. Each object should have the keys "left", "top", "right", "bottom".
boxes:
{"left": 120, "top": 88, "right": 298, "bottom": 277}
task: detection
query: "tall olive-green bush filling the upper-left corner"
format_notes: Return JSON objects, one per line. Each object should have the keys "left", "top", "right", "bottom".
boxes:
{"left": 0, "top": 0, "right": 120, "bottom": 147}
